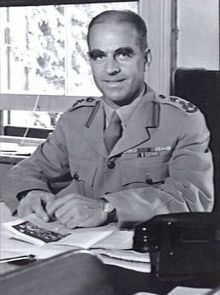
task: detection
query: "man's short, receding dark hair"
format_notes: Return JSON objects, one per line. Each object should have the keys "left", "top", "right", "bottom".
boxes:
{"left": 87, "top": 10, "right": 148, "bottom": 50}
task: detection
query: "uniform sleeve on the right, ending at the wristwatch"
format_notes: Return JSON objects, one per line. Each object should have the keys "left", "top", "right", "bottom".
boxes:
{"left": 105, "top": 111, "right": 214, "bottom": 226}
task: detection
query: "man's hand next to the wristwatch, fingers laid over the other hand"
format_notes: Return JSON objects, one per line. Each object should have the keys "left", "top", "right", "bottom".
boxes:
{"left": 46, "top": 193, "right": 107, "bottom": 228}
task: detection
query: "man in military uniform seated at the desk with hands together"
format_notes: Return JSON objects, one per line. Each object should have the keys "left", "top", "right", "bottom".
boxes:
{"left": 4, "top": 11, "right": 213, "bottom": 228}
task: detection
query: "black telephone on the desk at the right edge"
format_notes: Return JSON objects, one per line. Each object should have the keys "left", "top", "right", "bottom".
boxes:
{"left": 133, "top": 212, "right": 220, "bottom": 280}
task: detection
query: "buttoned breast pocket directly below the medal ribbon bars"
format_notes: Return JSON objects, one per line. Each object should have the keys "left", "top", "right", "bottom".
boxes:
{"left": 122, "top": 158, "right": 169, "bottom": 187}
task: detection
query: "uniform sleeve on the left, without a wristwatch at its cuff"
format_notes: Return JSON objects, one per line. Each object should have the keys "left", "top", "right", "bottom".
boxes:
{"left": 2, "top": 115, "right": 69, "bottom": 212}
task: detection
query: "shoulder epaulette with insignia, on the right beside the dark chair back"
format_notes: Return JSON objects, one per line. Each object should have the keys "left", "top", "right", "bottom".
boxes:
{"left": 158, "top": 94, "right": 198, "bottom": 114}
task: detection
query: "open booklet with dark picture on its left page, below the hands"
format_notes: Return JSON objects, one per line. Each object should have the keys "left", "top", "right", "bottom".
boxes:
{"left": 3, "top": 214, "right": 122, "bottom": 249}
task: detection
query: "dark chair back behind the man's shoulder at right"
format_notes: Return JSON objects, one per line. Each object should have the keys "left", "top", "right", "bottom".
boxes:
{"left": 172, "top": 68, "right": 220, "bottom": 211}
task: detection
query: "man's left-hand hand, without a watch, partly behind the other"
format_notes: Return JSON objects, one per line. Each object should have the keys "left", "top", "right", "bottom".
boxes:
{"left": 17, "top": 190, "right": 54, "bottom": 222}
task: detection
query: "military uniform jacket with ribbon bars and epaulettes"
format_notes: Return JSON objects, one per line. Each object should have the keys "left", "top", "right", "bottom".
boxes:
{"left": 4, "top": 88, "right": 213, "bottom": 225}
